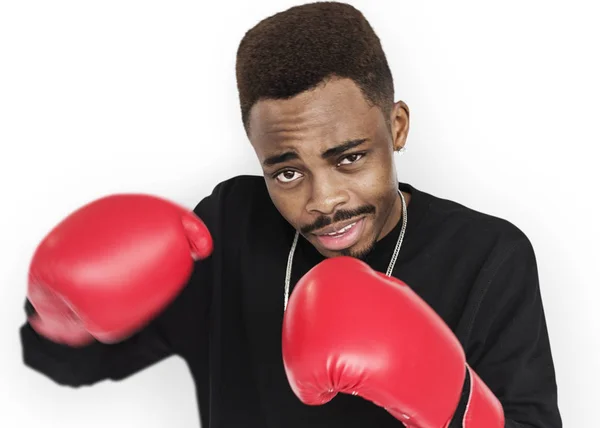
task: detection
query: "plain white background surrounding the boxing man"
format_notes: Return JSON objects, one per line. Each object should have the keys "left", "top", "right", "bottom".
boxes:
{"left": 0, "top": 0, "right": 600, "bottom": 428}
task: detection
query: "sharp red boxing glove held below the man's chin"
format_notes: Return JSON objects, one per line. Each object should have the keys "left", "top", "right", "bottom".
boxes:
{"left": 283, "top": 257, "right": 504, "bottom": 428}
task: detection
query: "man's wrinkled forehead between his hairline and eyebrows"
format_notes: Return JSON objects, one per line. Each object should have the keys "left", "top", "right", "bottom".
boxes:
{"left": 249, "top": 79, "right": 381, "bottom": 150}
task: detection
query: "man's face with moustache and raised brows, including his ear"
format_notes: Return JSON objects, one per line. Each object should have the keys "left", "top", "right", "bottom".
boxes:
{"left": 249, "top": 79, "right": 408, "bottom": 258}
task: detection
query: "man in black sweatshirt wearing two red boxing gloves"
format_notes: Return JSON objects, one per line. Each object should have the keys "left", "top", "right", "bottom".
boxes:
{"left": 21, "top": 3, "right": 561, "bottom": 428}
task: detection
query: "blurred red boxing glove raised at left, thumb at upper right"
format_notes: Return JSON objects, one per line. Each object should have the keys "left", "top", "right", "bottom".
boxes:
{"left": 27, "top": 194, "right": 212, "bottom": 346}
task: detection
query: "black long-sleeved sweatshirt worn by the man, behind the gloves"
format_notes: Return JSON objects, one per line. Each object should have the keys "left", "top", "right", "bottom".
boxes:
{"left": 21, "top": 176, "right": 562, "bottom": 428}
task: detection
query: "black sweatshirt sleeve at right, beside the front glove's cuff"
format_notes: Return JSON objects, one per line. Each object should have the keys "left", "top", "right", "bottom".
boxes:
{"left": 466, "top": 237, "right": 562, "bottom": 428}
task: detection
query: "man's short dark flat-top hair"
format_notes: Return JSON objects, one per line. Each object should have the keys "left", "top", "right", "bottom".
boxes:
{"left": 236, "top": 2, "right": 394, "bottom": 131}
